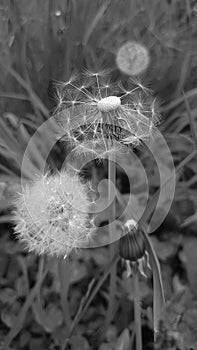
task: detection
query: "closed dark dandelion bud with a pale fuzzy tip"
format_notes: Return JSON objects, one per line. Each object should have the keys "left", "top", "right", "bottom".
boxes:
{"left": 119, "top": 220, "right": 145, "bottom": 262}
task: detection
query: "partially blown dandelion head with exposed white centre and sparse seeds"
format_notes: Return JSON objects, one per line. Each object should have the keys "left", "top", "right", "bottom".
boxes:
{"left": 55, "top": 73, "right": 158, "bottom": 157}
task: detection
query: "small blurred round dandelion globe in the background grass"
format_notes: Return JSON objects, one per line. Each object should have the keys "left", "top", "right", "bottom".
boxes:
{"left": 116, "top": 41, "right": 150, "bottom": 76}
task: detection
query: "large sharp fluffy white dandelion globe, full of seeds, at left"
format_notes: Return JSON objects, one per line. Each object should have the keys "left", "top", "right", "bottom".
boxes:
{"left": 14, "top": 172, "right": 94, "bottom": 257}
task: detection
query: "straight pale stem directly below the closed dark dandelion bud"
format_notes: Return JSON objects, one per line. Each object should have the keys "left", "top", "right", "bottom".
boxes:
{"left": 133, "top": 266, "right": 142, "bottom": 350}
